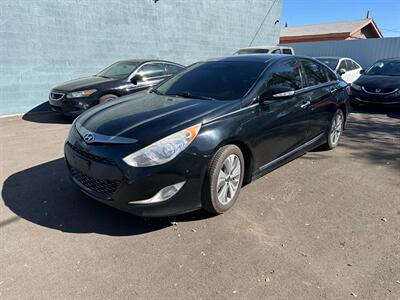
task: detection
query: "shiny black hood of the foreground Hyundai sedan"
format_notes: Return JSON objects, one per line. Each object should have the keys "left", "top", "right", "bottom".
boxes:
{"left": 76, "top": 91, "right": 236, "bottom": 143}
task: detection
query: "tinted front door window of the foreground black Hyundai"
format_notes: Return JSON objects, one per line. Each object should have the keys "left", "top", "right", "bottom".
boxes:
{"left": 266, "top": 60, "right": 303, "bottom": 90}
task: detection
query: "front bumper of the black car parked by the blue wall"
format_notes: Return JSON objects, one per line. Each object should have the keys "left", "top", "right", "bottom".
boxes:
{"left": 49, "top": 90, "right": 98, "bottom": 116}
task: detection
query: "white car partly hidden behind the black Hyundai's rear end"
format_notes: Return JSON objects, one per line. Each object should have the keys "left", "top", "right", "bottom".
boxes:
{"left": 316, "top": 57, "right": 363, "bottom": 83}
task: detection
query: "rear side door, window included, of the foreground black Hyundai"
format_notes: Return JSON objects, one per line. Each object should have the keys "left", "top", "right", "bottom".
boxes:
{"left": 301, "top": 59, "right": 339, "bottom": 140}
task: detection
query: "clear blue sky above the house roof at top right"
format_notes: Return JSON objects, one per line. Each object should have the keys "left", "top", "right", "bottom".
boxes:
{"left": 280, "top": 0, "right": 400, "bottom": 37}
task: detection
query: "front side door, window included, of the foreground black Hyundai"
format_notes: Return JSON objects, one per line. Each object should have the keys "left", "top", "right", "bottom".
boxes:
{"left": 250, "top": 58, "right": 309, "bottom": 172}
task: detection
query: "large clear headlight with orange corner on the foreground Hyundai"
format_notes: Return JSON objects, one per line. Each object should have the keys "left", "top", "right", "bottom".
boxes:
{"left": 123, "top": 124, "right": 201, "bottom": 167}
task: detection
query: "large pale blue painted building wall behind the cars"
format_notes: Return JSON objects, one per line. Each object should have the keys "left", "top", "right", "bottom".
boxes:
{"left": 0, "top": 0, "right": 282, "bottom": 115}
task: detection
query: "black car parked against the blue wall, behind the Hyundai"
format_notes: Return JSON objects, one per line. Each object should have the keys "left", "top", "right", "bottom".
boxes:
{"left": 49, "top": 60, "right": 184, "bottom": 116}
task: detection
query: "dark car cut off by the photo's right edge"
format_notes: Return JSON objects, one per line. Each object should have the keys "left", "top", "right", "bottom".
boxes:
{"left": 350, "top": 58, "right": 400, "bottom": 106}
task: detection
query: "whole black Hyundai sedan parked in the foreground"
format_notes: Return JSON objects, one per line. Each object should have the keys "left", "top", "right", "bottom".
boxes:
{"left": 65, "top": 55, "right": 348, "bottom": 217}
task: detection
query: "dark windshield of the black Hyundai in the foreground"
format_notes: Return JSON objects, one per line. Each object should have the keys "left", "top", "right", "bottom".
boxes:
{"left": 155, "top": 61, "right": 265, "bottom": 100}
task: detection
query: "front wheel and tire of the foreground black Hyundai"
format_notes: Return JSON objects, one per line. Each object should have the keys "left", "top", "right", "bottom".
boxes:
{"left": 202, "top": 145, "right": 245, "bottom": 214}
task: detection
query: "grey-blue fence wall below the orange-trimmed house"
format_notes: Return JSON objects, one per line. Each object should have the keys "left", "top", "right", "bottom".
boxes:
{"left": 287, "top": 37, "right": 400, "bottom": 68}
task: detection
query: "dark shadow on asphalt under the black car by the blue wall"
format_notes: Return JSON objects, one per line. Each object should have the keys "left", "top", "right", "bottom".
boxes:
{"left": 22, "top": 101, "right": 74, "bottom": 124}
